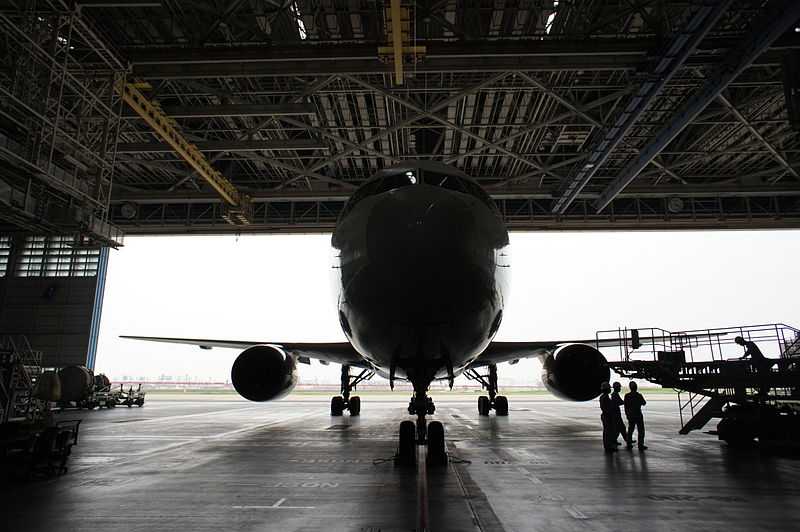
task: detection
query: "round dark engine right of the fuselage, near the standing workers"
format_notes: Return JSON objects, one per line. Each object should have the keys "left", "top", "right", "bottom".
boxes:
{"left": 542, "top": 344, "right": 611, "bottom": 401}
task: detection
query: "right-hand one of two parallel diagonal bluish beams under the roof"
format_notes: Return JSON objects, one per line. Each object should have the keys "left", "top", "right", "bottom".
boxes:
{"left": 594, "top": 0, "right": 800, "bottom": 212}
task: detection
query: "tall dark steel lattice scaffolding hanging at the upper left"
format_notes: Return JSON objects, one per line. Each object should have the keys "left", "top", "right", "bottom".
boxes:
{"left": 0, "top": 1, "right": 122, "bottom": 246}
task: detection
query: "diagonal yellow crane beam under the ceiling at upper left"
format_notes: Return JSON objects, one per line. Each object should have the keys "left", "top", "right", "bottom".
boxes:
{"left": 114, "top": 74, "right": 253, "bottom": 225}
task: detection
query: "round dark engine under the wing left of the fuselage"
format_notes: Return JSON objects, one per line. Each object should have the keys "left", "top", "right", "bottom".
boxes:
{"left": 231, "top": 345, "right": 298, "bottom": 401}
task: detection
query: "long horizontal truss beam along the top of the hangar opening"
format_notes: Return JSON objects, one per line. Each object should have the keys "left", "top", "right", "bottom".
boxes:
{"left": 112, "top": 194, "right": 800, "bottom": 234}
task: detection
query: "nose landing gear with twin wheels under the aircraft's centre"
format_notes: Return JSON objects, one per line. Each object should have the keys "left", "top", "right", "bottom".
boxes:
{"left": 394, "top": 390, "right": 447, "bottom": 467}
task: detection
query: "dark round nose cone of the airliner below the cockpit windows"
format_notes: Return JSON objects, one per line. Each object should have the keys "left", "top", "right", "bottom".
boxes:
{"left": 366, "top": 185, "right": 476, "bottom": 288}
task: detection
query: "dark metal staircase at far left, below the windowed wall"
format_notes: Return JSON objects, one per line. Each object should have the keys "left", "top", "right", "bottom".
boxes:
{"left": 0, "top": 336, "right": 45, "bottom": 423}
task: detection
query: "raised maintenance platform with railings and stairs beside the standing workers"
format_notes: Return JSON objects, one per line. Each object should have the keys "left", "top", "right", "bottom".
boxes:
{"left": 598, "top": 324, "right": 800, "bottom": 445}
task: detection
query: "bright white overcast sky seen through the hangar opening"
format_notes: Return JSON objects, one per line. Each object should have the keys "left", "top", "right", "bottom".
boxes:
{"left": 95, "top": 231, "right": 800, "bottom": 384}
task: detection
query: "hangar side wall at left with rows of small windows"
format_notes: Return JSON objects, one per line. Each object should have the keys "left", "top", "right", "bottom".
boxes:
{"left": 0, "top": 236, "right": 108, "bottom": 369}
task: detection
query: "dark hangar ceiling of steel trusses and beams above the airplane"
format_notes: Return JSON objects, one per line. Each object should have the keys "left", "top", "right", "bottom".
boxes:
{"left": 0, "top": 0, "right": 800, "bottom": 238}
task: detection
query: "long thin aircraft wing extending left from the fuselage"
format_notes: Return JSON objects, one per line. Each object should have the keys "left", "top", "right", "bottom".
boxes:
{"left": 120, "top": 335, "right": 369, "bottom": 368}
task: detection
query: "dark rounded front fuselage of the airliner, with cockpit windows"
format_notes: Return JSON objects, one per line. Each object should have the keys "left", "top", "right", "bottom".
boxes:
{"left": 332, "top": 162, "right": 509, "bottom": 390}
